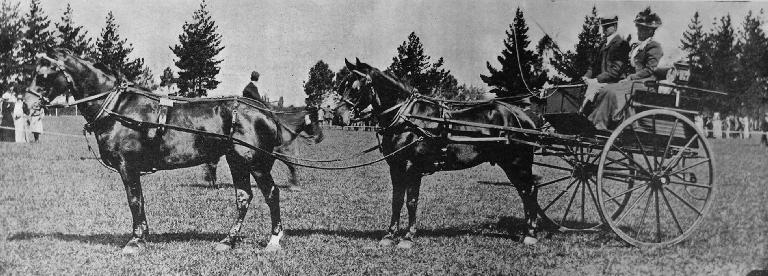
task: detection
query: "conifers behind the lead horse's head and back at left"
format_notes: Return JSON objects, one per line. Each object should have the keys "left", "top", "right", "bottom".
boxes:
{"left": 0, "top": 0, "right": 224, "bottom": 97}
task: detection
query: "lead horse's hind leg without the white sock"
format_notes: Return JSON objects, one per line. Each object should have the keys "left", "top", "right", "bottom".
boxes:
{"left": 216, "top": 156, "right": 253, "bottom": 251}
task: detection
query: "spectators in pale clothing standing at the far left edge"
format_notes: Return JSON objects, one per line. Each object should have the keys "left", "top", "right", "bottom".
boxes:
{"left": 0, "top": 90, "right": 44, "bottom": 143}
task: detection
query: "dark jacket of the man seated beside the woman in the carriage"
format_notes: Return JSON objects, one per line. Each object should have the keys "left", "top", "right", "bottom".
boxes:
{"left": 584, "top": 35, "right": 630, "bottom": 83}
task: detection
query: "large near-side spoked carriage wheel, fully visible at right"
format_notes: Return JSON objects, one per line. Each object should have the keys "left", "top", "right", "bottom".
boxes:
{"left": 597, "top": 109, "right": 715, "bottom": 246}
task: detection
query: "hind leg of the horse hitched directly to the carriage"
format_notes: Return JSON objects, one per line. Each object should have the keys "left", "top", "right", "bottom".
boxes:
{"left": 501, "top": 158, "right": 540, "bottom": 244}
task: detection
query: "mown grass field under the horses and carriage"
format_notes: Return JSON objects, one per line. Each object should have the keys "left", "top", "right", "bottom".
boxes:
{"left": 0, "top": 117, "right": 768, "bottom": 275}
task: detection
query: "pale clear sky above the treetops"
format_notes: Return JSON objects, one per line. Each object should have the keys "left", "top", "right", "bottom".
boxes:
{"left": 27, "top": 0, "right": 768, "bottom": 105}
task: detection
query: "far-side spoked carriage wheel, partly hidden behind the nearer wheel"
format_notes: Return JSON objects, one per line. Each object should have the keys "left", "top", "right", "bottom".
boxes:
{"left": 536, "top": 144, "right": 603, "bottom": 231}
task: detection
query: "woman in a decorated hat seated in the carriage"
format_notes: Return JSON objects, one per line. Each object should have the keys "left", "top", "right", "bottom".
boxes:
{"left": 588, "top": 7, "right": 664, "bottom": 130}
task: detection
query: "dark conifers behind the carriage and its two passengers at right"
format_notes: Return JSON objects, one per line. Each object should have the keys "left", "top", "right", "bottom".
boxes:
{"left": 492, "top": 7, "right": 768, "bottom": 116}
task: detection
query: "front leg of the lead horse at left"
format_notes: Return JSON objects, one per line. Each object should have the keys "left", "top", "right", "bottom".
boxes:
{"left": 118, "top": 162, "right": 149, "bottom": 254}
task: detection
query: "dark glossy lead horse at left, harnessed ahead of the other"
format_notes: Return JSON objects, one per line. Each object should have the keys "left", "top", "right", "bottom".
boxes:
{"left": 25, "top": 49, "right": 322, "bottom": 254}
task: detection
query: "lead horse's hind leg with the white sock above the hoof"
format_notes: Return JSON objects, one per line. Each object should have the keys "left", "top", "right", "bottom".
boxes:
{"left": 251, "top": 169, "right": 283, "bottom": 252}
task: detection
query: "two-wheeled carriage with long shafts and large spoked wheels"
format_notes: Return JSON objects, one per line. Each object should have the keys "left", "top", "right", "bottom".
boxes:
{"left": 410, "top": 64, "right": 725, "bottom": 246}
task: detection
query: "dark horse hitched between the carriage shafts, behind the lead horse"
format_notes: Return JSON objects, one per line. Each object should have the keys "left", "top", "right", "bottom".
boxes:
{"left": 344, "top": 60, "right": 540, "bottom": 248}
